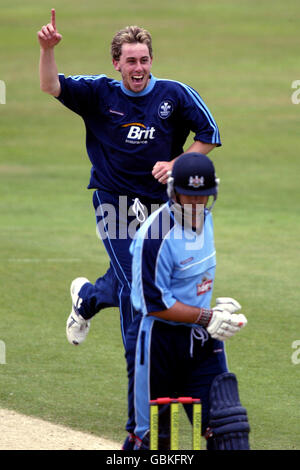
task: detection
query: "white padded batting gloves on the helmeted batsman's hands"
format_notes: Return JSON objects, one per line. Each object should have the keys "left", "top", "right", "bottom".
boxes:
{"left": 207, "top": 297, "right": 247, "bottom": 341}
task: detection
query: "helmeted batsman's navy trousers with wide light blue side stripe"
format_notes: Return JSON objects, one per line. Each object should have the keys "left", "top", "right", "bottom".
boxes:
{"left": 131, "top": 316, "right": 228, "bottom": 439}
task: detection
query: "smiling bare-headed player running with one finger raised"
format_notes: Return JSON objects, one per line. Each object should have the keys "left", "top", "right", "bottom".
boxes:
{"left": 38, "top": 10, "right": 221, "bottom": 346}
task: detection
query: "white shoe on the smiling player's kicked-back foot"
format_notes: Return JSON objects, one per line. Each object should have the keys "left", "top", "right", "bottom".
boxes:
{"left": 66, "top": 277, "right": 91, "bottom": 346}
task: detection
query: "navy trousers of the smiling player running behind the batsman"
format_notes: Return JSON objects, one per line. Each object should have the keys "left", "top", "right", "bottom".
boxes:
{"left": 79, "top": 190, "right": 167, "bottom": 432}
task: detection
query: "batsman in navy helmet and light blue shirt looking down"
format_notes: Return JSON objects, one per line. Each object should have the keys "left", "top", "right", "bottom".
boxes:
{"left": 131, "top": 152, "right": 249, "bottom": 450}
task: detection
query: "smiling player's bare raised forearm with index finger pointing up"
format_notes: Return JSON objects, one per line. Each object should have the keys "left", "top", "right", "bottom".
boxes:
{"left": 37, "top": 9, "right": 62, "bottom": 97}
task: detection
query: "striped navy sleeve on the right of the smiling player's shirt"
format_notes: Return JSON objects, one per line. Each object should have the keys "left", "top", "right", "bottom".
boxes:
{"left": 180, "top": 83, "right": 222, "bottom": 146}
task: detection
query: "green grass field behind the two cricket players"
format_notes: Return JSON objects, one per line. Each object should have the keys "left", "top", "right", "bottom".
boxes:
{"left": 0, "top": 0, "right": 300, "bottom": 450}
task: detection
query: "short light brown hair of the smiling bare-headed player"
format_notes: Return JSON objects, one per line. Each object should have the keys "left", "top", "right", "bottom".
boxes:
{"left": 110, "top": 26, "right": 152, "bottom": 60}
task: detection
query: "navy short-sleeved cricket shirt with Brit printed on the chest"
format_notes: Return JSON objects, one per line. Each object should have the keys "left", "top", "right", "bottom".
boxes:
{"left": 58, "top": 74, "right": 221, "bottom": 200}
